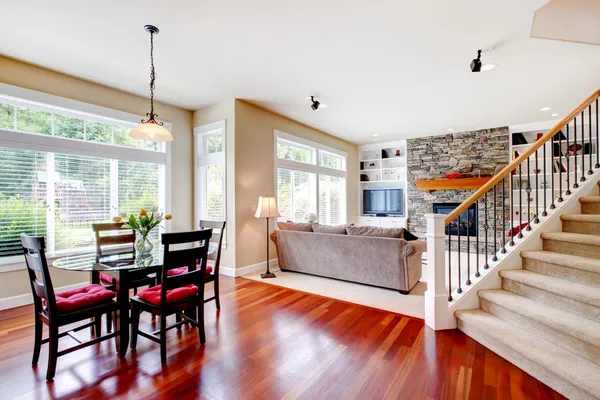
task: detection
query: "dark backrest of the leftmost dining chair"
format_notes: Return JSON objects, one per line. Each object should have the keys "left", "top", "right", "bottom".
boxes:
{"left": 21, "top": 235, "right": 58, "bottom": 319}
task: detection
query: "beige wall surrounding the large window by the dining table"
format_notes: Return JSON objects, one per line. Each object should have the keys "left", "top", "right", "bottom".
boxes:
{"left": 0, "top": 56, "right": 194, "bottom": 298}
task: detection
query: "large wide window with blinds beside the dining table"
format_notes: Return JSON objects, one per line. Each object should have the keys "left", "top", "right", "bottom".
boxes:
{"left": 0, "top": 86, "right": 168, "bottom": 262}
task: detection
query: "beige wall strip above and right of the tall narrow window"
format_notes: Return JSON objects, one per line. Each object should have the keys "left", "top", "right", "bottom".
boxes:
{"left": 192, "top": 99, "right": 236, "bottom": 268}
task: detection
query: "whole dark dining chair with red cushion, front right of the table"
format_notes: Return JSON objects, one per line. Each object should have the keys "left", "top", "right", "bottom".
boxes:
{"left": 131, "top": 229, "right": 212, "bottom": 365}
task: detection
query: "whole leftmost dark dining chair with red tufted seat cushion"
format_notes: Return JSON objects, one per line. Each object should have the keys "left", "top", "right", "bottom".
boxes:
{"left": 21, "top": 236, "right": 118, "bottom": 380}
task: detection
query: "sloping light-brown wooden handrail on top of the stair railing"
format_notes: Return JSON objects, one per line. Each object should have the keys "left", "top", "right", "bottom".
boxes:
{"left": 444, "top": 89, "right": 600, "bottom": 225}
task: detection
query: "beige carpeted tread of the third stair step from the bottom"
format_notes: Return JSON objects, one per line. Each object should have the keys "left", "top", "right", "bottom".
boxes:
{"left": 499, "top": 269, "right": 600, "bottom": 307}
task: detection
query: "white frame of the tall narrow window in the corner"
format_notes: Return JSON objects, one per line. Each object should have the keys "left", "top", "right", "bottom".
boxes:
{"left": 194, "top": 120, "right": 227, "bottom": 249}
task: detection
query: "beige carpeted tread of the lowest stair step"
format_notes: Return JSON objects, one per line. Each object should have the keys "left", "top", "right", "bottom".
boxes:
{"left": 456, "top": 310, "right": 600, "bottom": 398}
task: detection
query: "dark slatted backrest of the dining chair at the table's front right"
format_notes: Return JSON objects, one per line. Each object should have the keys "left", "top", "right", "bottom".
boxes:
{"left": 161, "top": 229, "right": 212, "bottom": 307}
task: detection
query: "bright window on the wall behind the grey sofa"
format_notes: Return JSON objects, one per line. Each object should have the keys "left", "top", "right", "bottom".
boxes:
{"left": 275, "top": 131, "right": 346, "bottom": 225}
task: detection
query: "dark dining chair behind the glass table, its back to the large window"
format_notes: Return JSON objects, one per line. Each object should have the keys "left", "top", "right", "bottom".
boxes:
{"left": 92, "top": 222, "right": 156, "bottom": 332}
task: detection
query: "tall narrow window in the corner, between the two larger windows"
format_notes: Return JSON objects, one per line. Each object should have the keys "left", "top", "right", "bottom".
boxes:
{"left": 194, "top": 121, "right": 227, "bottom": 227}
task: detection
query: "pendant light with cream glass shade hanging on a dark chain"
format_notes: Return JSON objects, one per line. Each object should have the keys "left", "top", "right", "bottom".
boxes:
{"left": 129, "top": 25, "right": 173, "bottom": 142}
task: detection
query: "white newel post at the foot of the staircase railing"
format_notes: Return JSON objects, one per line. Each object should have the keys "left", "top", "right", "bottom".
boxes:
{"left": 425, "top": 214, "right": 455, "bottom": 330}
